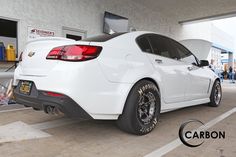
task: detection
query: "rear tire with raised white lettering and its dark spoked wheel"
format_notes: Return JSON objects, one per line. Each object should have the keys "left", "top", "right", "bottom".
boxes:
{"left": 117, "top": 80, "right": 160, "bottom": 135}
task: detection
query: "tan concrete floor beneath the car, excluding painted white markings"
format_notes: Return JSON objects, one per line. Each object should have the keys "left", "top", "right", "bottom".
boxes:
{"left": 0, "top": 82, "right": 236, "bottom": 157}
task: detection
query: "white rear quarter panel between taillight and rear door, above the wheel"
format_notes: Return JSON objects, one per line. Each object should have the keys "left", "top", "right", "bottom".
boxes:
{"left": 91, "top": 34, "right": 154, "bottom": 84}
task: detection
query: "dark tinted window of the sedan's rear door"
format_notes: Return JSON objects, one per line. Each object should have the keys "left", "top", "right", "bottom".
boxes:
{"left": 148, "top": 35, "right": 177, "bottom": 59}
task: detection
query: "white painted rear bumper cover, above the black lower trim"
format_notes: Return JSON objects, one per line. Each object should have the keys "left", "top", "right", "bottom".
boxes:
{"left": 13, "top": 60, "right": 133, "bottom": 120}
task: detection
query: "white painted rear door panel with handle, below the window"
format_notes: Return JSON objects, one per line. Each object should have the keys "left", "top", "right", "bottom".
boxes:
{"left": 147, "top": 54, "right": 189, "bottom": 103}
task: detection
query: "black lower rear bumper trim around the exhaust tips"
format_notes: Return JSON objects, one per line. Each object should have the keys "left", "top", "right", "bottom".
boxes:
{"left": 14, "top": 84, "right": 93, "bottom": 119}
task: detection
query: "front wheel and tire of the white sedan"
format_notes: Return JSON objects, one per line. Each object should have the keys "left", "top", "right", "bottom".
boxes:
{"left": 208, "top": 80, "right": 222, "bottom": 107}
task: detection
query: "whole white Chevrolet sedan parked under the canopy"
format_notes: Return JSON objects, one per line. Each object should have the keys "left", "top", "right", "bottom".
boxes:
{"left": 14, "top": 31, "right": 222, "bottom": 135}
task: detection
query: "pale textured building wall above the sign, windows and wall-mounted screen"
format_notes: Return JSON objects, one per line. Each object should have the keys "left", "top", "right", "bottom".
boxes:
{"left": 0, "top": 0, "right": 180, "bottom": 55}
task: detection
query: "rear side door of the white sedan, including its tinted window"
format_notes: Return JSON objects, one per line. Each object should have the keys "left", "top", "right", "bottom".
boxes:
{"left": 147, "top": 35, "right": 189, "bottom": 103}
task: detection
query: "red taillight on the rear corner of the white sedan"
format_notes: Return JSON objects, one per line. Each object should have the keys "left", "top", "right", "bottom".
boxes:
{"left": 47, "top": 45, "right": 102, "bottom": 61}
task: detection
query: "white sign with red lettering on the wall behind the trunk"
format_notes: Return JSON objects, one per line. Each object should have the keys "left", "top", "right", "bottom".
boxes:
{"left": 28, "top": 27, "right": 55, "bottom": 41}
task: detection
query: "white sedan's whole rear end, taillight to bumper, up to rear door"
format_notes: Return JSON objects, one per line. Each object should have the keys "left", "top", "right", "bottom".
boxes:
{"left": 14, "top": 32, "right": 147, "bottom": 120}
